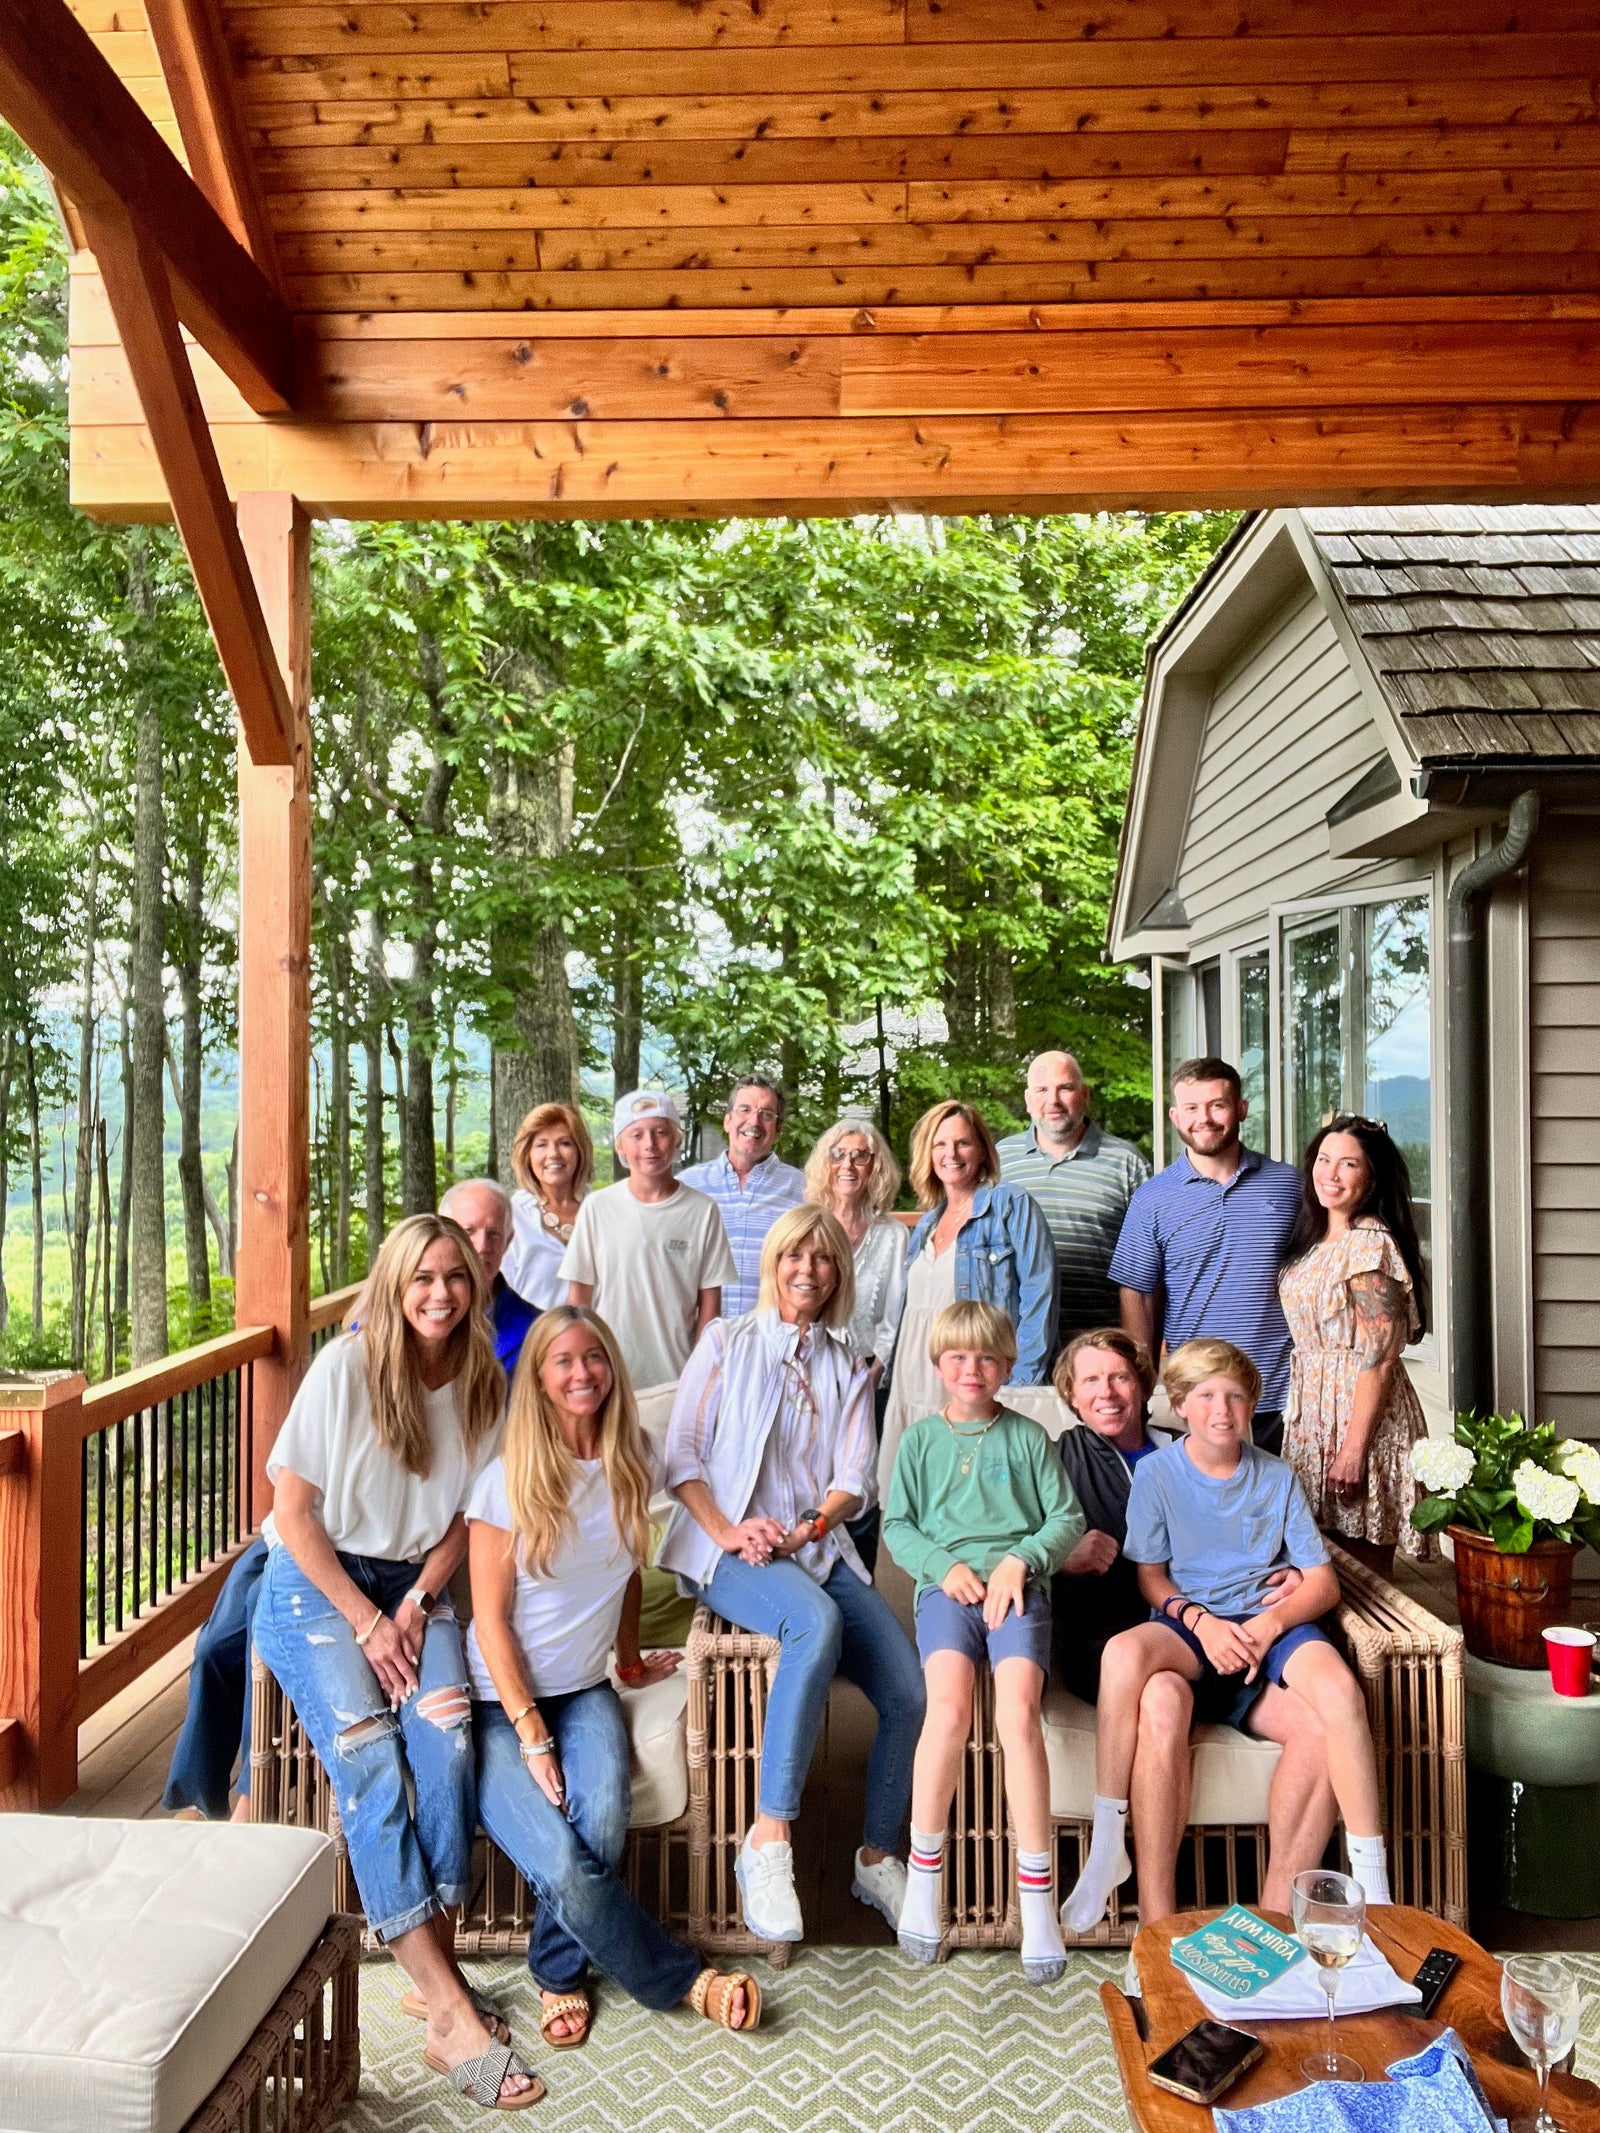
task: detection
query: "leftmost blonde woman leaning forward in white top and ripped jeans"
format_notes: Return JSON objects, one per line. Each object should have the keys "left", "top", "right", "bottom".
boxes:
{"left": 254, "top": 1214, "right": 544, "bottom": 2112}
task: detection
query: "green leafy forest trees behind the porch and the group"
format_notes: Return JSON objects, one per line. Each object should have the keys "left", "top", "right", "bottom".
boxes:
{"left": 0, "top": 137, "right": 1229, "bottom": 1372}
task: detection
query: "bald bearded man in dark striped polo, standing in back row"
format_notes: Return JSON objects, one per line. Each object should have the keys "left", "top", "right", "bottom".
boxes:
{"left": 1001, "top": 1052, "right": 1150, "bottom": 1346}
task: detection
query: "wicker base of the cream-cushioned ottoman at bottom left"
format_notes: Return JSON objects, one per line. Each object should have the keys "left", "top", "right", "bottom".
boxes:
{"left": 183, "top": 1915, "right": 361, "bottom": 2133}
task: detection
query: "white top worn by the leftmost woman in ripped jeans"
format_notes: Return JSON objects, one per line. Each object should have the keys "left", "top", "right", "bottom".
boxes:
{"left": 267, "top": 1333, "right": 499, "bottom": 1563}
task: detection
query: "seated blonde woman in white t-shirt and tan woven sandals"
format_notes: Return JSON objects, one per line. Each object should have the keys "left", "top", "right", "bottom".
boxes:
{"left": 467, "top": 1305, "right": 762, "bottom": 2050}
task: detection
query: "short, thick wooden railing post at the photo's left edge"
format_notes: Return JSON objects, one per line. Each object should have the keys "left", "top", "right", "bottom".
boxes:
{"left": 0, "top": 1372, "right": 83, "bottom": 1809}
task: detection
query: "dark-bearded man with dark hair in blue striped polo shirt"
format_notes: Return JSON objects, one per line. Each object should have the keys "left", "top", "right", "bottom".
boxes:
{"left": 1109, "top": 1058, "right": 1301, "bottom": 1453}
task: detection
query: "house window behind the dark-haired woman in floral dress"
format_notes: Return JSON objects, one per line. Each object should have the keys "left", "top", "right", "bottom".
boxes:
{"left": 1288, "top": 896, "right": 1434, "bottom": 1261}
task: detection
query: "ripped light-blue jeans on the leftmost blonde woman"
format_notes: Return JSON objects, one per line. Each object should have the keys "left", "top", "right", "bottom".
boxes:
{"left": 256, "top": 1544, "right": 478, "bottom": 1941}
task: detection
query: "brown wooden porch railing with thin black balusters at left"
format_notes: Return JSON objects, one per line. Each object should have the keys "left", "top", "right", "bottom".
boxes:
{"left": 0, "top": 1288, "right": 356, "bottom": 1807}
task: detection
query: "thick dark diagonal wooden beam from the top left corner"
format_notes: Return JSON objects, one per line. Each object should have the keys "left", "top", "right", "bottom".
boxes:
{"left": 0, "top": 0, "right": 294, "bottom": 414}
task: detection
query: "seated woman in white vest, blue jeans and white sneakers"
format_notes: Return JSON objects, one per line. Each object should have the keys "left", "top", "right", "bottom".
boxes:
{"left": 659, "top": 1207, "right": 924, "bottom": 1941}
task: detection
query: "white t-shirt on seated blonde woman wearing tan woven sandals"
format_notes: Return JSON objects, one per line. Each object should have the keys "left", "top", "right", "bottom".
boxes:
{"left": 467, "top": 1459, "right": 638, "bottom": 1704}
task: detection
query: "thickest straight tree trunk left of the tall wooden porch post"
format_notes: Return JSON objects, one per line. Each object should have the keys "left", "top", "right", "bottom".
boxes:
{"left": 128, "top": 693, "right": 166, "bottom": 1369}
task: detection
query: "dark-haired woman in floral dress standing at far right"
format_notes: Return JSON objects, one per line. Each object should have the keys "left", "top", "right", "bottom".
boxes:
{"left": 1278, "top": 1116, "right": 1431, "bottom": 1574}
